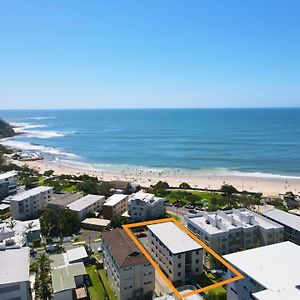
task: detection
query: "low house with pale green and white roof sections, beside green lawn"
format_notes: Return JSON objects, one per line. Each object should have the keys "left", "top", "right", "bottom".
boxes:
{"left": 49, "top": 246, "right": 88, "bottom": 300}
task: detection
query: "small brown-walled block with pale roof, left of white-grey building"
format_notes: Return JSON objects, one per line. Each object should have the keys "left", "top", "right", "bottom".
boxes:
{"left": 103, "top": 194, "right": 129, "bottom": 220}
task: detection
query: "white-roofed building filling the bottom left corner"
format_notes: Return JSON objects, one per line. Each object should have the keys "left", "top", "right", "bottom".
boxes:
{"left": 0, "top": 247, "right": 31, "bottom": 300}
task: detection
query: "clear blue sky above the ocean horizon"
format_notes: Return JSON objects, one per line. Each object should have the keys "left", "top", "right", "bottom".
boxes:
{"left": 0, "top": 0, "right": 300, "bottom": 109}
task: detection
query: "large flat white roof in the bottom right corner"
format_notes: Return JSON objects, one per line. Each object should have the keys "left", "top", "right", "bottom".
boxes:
{"left": 224, "top": 242, "right": 300, "bottom": 300}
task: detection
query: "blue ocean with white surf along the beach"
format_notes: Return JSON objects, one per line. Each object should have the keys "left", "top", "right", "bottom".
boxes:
{"left": 0, "top": 108, "right": 300, "bottom": 177}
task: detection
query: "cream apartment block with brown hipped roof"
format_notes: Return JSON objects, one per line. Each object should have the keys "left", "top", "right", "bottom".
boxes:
{"left": 102, "top": 229, "right": 155, "bottom": 300}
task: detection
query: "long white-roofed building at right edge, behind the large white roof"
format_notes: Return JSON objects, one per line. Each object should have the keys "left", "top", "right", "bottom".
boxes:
{"left": 263, "top": 209, "right": 300, "bottom": 245}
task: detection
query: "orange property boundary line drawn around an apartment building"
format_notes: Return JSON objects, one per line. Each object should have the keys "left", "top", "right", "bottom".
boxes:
{"left": 123, "top": 218, "right": 244, "bottom": 299}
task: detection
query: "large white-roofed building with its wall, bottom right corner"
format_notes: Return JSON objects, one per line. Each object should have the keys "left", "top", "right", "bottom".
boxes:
{"left": 224, "top": 241, "right": 300, "bottom": 300}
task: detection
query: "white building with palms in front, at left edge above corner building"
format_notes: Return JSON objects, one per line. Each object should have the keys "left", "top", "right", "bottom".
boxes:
{"left": 0, "top": 219, "right": 41, "bottom": 250}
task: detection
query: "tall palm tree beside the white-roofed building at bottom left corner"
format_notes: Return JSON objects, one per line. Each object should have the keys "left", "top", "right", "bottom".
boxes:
{"left": 32, "top": 253, "right": 51, "bottom": 300}
